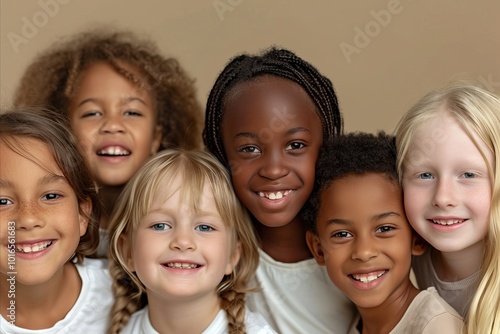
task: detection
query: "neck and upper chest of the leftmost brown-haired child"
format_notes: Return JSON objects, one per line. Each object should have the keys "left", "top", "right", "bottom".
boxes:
{"left": 0, "top": 262, "right": 82, "bottom": 329}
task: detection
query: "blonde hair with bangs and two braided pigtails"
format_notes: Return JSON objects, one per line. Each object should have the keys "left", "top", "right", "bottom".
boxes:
{"left": 109, "top": 149, "right": 259, "bottom": 333}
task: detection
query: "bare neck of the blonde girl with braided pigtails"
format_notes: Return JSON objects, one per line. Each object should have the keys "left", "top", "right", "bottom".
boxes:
{"left": 148, "top": 291, "right": 221, "bottom": 334}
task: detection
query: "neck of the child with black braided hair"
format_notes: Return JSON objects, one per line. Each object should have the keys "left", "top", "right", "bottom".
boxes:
{"left": 254, "top": 217, "right": 312, "bottom": 263}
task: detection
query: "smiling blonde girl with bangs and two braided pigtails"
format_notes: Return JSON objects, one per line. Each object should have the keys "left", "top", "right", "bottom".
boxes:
{"left": 109, "top": 149, "right": 275, "bottom": 334}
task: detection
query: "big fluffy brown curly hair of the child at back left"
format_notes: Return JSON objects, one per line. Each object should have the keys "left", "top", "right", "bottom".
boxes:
{"left": 14, "top": 28, "right": 203, "bottom": 150}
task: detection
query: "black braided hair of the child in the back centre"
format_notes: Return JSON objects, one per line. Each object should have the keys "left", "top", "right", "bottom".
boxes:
{"left": 203, "top": 47, "right": 343, "bottom": 165}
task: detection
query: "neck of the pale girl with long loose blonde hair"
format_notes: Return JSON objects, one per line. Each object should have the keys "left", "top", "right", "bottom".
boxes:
{"left": 431, "top": 242, "right": 484, "bottom": 282}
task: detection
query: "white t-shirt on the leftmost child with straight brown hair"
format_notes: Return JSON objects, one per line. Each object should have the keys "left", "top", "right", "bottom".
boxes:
{"left": 0, "top": 258, "right": 114, "bottom": 334}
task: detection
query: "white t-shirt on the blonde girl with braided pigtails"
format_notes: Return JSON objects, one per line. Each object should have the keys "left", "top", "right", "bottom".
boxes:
{"left": 120, "top": 306, "right": 276, "bottom": 334}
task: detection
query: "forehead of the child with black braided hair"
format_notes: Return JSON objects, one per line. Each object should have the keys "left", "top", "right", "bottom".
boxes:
{"left": 222, "top": 75, "right": 321, "bottom": 131}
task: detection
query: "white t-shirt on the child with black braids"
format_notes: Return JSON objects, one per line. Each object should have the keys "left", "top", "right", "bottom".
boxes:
{"left": 247, "top": 249, "right": 357, "bottom": 334}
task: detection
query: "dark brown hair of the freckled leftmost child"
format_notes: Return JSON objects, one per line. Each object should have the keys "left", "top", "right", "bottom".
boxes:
{"left": 0, "top": 108, "right": 101, "bottom": 263}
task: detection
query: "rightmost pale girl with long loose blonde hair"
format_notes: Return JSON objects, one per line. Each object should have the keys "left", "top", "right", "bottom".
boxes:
{"left": 396, "top": 84, "right": 500, "bottom": 334}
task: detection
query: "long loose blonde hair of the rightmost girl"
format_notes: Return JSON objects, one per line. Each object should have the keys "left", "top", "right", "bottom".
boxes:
{"left": 396, "top": 83, "right": 500, "bottom": 334}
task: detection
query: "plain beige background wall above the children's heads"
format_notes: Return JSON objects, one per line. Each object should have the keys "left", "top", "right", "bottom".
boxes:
{"left": 0, "top": 0, "right": 500, "bottom": 132}
